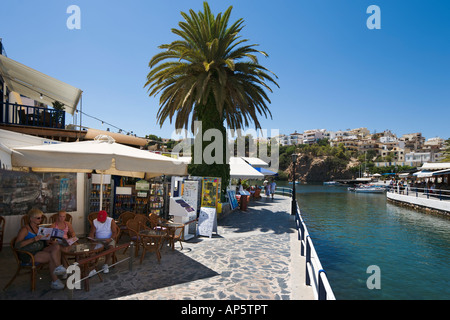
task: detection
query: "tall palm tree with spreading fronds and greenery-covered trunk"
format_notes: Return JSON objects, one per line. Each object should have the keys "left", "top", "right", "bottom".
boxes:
{"left": 144, "top": 2, "right": 278, "bottom": 192}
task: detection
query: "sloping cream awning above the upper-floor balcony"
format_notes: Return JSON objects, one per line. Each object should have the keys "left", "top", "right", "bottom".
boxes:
{"left": 0, "top": 55, "right": 82, "bottom": 115}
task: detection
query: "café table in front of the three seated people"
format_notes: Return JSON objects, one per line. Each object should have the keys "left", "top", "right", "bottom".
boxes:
{"left": 61, "top": 239, "right": 104, "bottom": 291}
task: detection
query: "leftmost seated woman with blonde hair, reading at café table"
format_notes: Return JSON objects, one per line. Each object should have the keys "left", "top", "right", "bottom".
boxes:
{"left": 15, "top": 208, "right": 66, "bottom": 289}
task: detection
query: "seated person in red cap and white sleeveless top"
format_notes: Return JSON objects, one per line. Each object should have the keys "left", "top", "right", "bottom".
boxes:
{"left": 89, "top": 210, "right": 118, "bottom": 273}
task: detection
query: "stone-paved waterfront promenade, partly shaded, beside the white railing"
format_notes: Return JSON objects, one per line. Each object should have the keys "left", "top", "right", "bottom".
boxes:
{"left": 0, "top": 195, "right": 313, "bottom": 300}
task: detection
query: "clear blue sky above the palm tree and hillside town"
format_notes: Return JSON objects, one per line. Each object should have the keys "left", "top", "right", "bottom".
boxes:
{"left": 0, "top": 0, "right": 450, "bottom": 139}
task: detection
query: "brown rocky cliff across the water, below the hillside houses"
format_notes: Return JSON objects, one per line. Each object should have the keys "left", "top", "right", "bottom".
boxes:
{"left": 286, "top": 154, "right": 356, "bottom": 182}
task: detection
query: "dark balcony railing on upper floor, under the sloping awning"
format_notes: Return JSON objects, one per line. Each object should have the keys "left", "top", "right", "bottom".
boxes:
{"left": 0, "top": 102, "right": 66, "bottom": 129}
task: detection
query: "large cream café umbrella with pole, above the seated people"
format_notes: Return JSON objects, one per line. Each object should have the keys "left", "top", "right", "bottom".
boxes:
{"left": 11, "top": 136, "right": 187, "bottom": 210}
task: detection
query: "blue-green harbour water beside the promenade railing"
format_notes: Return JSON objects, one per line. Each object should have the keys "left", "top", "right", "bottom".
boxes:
{"left": 278, "top": 183, "right": 450, "bottom": 300}
